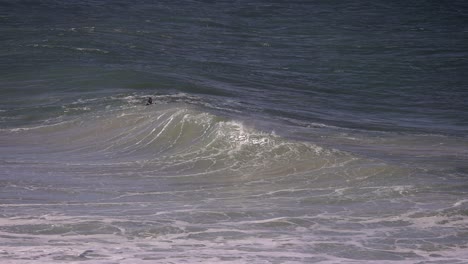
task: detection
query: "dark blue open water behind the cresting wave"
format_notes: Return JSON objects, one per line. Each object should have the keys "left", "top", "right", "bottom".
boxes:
{"left": 1, "top": 1, "right": 468, "bottom": 134}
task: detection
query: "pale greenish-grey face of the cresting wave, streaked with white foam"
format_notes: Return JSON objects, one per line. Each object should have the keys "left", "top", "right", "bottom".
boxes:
{"left": 3, "top": 103, "right": 354, "bottom": 193}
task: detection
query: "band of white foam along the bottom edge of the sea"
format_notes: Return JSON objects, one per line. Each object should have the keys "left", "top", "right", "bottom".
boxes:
{"left": 0, "top": 223, "right": 468, "bottom": 264}
